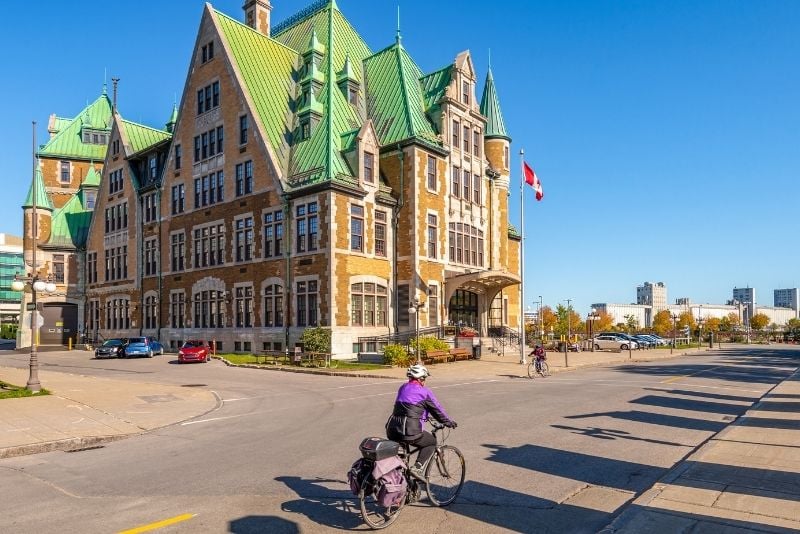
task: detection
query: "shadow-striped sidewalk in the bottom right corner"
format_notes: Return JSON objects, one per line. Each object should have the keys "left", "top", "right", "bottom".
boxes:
{"left": 602, "top": 371, "right": 800, "bottom": 534}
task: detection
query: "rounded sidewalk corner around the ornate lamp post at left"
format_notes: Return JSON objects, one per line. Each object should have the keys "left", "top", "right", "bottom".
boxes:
{"left": 0, "top": 367, "right": 218, "bottom": 458}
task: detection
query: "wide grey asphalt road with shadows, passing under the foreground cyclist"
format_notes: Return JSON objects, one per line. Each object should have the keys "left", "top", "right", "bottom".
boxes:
{"left": 0, "top": 347, "right": 800, "bottom": 533}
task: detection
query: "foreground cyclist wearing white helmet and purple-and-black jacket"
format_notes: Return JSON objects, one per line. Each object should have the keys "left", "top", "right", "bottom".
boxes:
{"left": 386, "top": 364, "right": 458, "bottom": 480}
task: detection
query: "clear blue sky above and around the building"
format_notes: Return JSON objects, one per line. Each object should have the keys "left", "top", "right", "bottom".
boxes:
{"left": 0, "top": 0, "right": 800, "bottom": 313}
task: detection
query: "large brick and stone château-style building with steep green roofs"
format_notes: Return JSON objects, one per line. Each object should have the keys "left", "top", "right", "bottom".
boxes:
{"left": 87, "top": 0, "right": 520, "bottom": 355}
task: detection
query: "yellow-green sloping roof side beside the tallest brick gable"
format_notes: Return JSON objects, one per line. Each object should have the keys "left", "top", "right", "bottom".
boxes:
{"left": 215, "top": 11, "right": 299, "bottom": 170}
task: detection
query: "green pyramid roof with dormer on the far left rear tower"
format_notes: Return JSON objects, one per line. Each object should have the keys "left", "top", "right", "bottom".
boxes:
{"left": 39, "top": 92, "right": 111, "bottom": 161}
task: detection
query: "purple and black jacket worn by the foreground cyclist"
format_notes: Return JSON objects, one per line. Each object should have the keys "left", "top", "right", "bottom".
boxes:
{"left": 386, "top": 380, "right": 450, "bottom": 441}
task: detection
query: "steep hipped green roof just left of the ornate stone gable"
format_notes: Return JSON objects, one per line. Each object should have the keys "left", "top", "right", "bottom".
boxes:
{"left": 364, "top": 43, "right": 437, "bottom": 145}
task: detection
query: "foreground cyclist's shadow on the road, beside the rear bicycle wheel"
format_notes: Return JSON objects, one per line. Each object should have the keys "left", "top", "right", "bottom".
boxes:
{"left": 275, "top": 476, "right": 364, "bottom": 530}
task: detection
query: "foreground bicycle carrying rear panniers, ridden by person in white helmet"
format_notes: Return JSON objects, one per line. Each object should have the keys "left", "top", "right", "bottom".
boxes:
{"left": 358, "top": 423, "right": 466, "bottom": 530}
